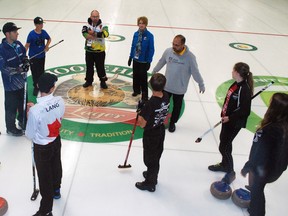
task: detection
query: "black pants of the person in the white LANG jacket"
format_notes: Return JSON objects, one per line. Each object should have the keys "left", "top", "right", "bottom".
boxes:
{"left": 34, "top": 136, "right": 62, "bottom": 213}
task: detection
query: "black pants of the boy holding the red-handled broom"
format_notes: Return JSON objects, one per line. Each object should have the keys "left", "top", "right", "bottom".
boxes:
{"left": 143, "top": 125, "right": 165, "bottom": 185}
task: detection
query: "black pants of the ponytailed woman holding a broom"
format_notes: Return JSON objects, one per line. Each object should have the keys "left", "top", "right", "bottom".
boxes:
{"left": 219, "top": 122, "right": 241, "bottom": 173}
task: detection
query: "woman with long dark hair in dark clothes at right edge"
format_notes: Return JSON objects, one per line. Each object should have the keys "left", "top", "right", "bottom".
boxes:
{"left": 241, "top": 93, "right": 288, "bottom": 216}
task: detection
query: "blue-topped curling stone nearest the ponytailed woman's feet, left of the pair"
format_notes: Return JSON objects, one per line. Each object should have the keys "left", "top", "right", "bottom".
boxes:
{"left": 210, "top": 181, "right": 232, "bottom": 200}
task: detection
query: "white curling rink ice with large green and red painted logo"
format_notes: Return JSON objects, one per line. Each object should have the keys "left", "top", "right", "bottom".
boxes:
{"left": 0, "top": 0, "right": 288, "bottom": 216}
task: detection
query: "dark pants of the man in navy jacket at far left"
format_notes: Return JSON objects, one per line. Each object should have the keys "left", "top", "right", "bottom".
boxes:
{"left": 4, "top": 88, "right": 26, "bottom": 130}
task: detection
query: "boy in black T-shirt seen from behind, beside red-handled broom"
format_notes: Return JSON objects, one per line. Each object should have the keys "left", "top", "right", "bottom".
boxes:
{"left": 135, "top": 74, "right": 170, "bottom": 192}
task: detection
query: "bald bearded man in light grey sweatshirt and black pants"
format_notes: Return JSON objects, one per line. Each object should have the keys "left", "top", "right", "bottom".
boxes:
{"left": 152, "top": 35, "right": 205, "bottom": 133}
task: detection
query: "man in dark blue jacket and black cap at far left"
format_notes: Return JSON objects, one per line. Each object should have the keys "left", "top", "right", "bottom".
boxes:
{"left": 0, "top": 22, "right": 29, "bottom": 136}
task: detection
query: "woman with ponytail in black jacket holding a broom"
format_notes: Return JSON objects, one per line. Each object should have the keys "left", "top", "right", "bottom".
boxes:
{"left": 208, "top": 62, "right": 254, "bottom": 184}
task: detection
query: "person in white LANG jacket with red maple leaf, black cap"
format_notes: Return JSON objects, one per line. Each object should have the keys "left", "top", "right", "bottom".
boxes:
{"left": 25, "top": 73, "right": 65, "bottom": 216}
